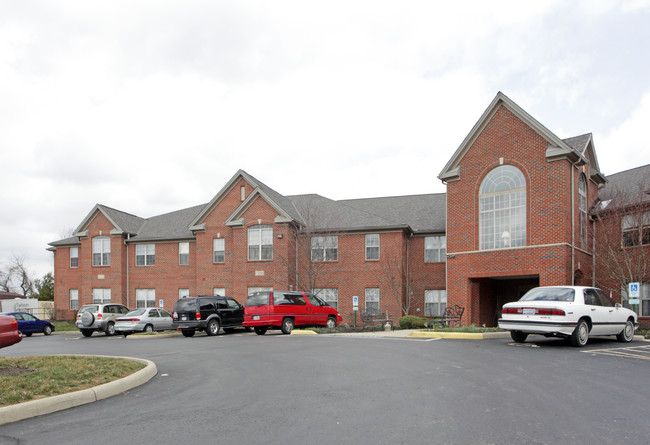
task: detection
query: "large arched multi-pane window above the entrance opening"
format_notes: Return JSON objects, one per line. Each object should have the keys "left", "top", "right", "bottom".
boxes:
{"left": 479, "top": 165, "right": 526, "bottom": 250}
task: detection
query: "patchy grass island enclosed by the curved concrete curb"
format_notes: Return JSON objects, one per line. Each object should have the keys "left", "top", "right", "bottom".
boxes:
{"left": 0, "top": 355, "right": 145, "bottom": 407}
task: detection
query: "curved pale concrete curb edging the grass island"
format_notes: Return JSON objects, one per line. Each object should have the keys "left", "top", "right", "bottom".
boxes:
{"left": 0, "top": 355, "right": 158, "bottom": 425}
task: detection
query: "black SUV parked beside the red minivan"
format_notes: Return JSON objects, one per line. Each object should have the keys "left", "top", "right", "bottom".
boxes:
{"left": 172, "top": 295, "right": 244, "bottom": 337}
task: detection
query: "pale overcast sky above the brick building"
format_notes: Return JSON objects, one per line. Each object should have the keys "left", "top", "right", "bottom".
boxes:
{"left": 0, "top": 0, "right": 650, "bottom": 277}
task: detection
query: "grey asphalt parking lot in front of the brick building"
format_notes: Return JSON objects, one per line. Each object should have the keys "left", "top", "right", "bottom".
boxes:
{"left": 0, "top": 332, "right": 650, "bottom": 444}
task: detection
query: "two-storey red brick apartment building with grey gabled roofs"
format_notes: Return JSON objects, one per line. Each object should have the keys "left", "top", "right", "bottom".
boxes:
{"left": 50, "top": 93, "right": 650, "bottom": 326}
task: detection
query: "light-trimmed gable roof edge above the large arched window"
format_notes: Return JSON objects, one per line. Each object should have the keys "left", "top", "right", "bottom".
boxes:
{"left": 438, "top": 91, "right": 588, "bottom": 182}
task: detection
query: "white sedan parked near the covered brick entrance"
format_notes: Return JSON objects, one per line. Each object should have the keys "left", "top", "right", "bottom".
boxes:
{"left": 499, "top": 286, "right": 638, "bottom": 347}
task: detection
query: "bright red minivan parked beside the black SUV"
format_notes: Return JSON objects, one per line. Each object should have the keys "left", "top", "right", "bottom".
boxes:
{"left": 244, "top": 291, "right": 342, "bottom": 335}
